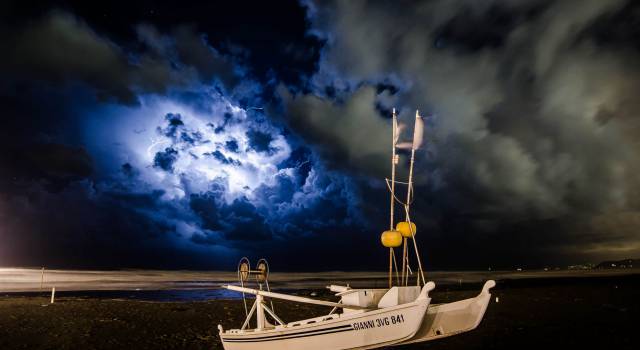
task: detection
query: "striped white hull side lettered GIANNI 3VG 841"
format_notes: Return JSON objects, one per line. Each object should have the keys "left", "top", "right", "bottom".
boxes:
{"left": 220, "top": 292, "right": 431, "bottom": 350}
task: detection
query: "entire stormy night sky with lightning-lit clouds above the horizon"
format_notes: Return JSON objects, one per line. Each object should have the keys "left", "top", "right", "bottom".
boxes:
{"left": 0, "top": 0, "right": 640, "bottom": 271}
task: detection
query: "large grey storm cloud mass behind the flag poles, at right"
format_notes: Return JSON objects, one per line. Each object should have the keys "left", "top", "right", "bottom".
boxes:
{"left": 284, "top": 0, "right": 640, "bottom": 258}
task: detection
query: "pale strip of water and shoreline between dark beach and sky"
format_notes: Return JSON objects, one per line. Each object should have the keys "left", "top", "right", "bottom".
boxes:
{"left": 0, "top": 268, "right": 640, "bottom": 294}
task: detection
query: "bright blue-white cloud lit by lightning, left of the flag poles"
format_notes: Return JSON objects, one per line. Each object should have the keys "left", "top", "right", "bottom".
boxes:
{"left": 74, "top": 84, "right": 364, "bottom": 251}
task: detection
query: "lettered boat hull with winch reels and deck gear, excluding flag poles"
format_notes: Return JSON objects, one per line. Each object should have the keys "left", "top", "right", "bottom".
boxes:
{"left": 218, "top": 258, "right": 435, "bottom": 350}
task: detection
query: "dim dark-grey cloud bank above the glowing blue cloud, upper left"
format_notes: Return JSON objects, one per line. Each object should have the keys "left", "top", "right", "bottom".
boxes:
{"left": 0, "top": 11, "right": 237, "bottom": 103}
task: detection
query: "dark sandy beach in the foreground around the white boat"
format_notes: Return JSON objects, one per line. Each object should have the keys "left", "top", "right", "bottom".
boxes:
{"left": 0, "top": 274, "right": 640, "bottom": 350}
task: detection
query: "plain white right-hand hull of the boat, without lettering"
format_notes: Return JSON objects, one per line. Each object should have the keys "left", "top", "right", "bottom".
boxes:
{"left": 395, "top": 280, "right": 495, "bottom": 345}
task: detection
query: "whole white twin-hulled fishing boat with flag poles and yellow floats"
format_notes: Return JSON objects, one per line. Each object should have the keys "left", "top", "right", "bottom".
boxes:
{"left": 218, "top": 109, "right": 495, "bottom": 350}
